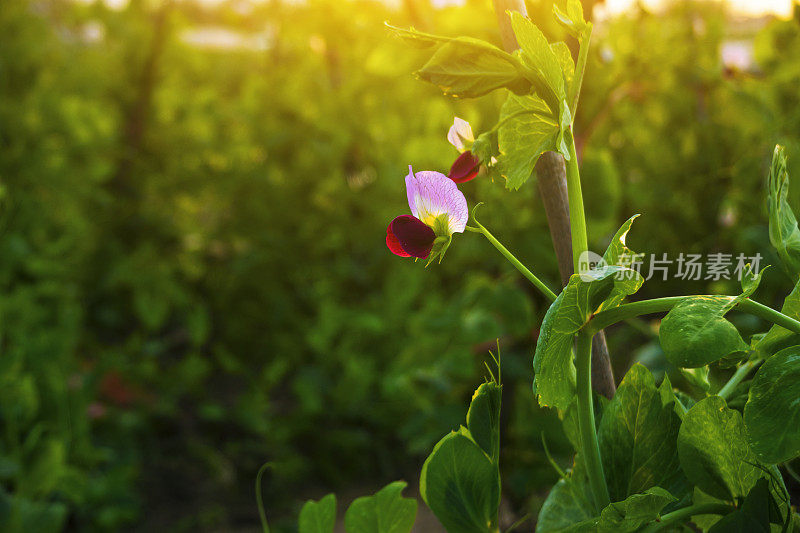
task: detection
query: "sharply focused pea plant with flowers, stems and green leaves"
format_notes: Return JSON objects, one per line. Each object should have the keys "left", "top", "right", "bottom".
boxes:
{"left": 270, "top": 0, "right": 800, "bottom": 533}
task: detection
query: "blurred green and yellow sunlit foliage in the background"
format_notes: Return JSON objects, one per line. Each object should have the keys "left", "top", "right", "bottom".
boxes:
{"left": 0, "top": 0, "right": 800, "bottom": 531}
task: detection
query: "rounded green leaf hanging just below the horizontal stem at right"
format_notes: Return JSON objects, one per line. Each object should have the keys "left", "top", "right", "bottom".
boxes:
{"left": 659, "top": 296, "right": 748, "bottom": 368}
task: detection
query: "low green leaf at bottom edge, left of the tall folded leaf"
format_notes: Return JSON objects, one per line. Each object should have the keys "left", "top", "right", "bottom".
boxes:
{"left": 344, "top": 481, "right": 417, "bottom": 533}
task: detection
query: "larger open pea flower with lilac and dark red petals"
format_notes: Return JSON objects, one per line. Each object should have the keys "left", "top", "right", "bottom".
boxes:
{"left": 386, "top": 165, "right": 469, "bottom": 264}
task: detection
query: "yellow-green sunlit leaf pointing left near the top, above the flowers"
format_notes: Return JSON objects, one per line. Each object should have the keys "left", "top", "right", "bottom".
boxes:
{"left": 417, "top": 37, "right": 530, "bottom": 98}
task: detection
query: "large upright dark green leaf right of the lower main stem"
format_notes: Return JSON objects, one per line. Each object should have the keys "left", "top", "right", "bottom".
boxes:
{"left": 598, "top": 364, "right": 686, "bottom": 505}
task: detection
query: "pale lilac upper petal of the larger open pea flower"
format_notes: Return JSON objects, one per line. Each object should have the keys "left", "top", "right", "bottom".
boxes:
{"left": 406, "top": 167, "right": 469, "bottom": 234}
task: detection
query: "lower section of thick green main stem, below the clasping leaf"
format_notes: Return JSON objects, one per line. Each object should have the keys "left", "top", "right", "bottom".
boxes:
{"left": 575, "top": 332, "right": 611, "bottom": 512}
